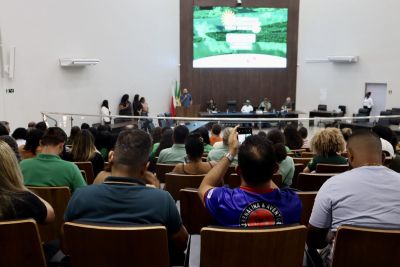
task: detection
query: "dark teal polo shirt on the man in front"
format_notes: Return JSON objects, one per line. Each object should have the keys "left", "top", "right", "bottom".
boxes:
{"left": 64, "top": 177, "right": 182, "bottom": 235}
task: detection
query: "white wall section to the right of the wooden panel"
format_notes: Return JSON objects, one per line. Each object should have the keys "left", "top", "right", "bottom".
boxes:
{"left": 296, "top": 0, "right": 400, "bottom": 115}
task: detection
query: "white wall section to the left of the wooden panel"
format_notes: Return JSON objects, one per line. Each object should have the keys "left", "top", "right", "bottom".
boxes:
{"left": 0, "top": 0, "right": 179, "bottom": 128}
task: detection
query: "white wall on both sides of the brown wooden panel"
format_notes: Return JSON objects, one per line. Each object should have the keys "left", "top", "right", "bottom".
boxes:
{"left": 0, "top": 0, "right": 400, "bottom": 128}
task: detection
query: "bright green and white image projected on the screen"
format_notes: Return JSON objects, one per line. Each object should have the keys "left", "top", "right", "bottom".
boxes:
{"left": 193, "top": 6, "right": 288, "bottom": 68}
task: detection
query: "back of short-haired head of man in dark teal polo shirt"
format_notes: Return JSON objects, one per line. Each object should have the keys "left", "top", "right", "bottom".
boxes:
{"left": 113, "top": 129, "right": 151, "bottom": 170}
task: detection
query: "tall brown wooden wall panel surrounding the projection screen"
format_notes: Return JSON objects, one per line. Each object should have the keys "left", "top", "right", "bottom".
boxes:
{"left": 180, "top": 0, "right": 299, "bottom": 110}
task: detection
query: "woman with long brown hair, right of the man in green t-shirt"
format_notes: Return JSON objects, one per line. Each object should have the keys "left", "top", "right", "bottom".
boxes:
{"left": 65, "top": 130, "right": 104, "bottom": 176}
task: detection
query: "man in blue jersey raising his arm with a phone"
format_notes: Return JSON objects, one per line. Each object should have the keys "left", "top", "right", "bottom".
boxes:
{"left": 198, "top": 127, "right": 301, "bottom": 227}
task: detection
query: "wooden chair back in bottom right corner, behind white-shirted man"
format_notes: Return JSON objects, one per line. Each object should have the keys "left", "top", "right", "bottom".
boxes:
{"left": 332, "top": 226, "right": 400, "bottom": 267}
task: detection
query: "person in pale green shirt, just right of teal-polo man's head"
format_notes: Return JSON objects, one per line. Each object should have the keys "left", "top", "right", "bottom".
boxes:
{"left": 157, "top": 125, "right": 189, "bottom": 164}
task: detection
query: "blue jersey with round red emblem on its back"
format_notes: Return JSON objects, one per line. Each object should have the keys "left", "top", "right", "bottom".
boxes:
{"left": 204, "top": 187, "right": 301, "bottom": 227}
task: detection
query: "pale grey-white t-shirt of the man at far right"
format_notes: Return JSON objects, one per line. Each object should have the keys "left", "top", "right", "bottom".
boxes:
{"left": 310, "top": 166, "right": 400, "bottom": 231}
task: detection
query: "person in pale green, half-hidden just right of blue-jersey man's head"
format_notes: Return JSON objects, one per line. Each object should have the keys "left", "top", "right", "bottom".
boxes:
{"left": 267, "top": 129, "right": 294, "bottom": 186}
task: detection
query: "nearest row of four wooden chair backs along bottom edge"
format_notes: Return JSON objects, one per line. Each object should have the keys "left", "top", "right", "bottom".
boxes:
{"left": 0, "top": 220, "right": 400, "bottom": 267}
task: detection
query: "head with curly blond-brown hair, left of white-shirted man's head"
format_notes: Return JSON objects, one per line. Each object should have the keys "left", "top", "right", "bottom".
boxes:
{"left": 311, "top": 128, "right": 345, "bottom": 157}
